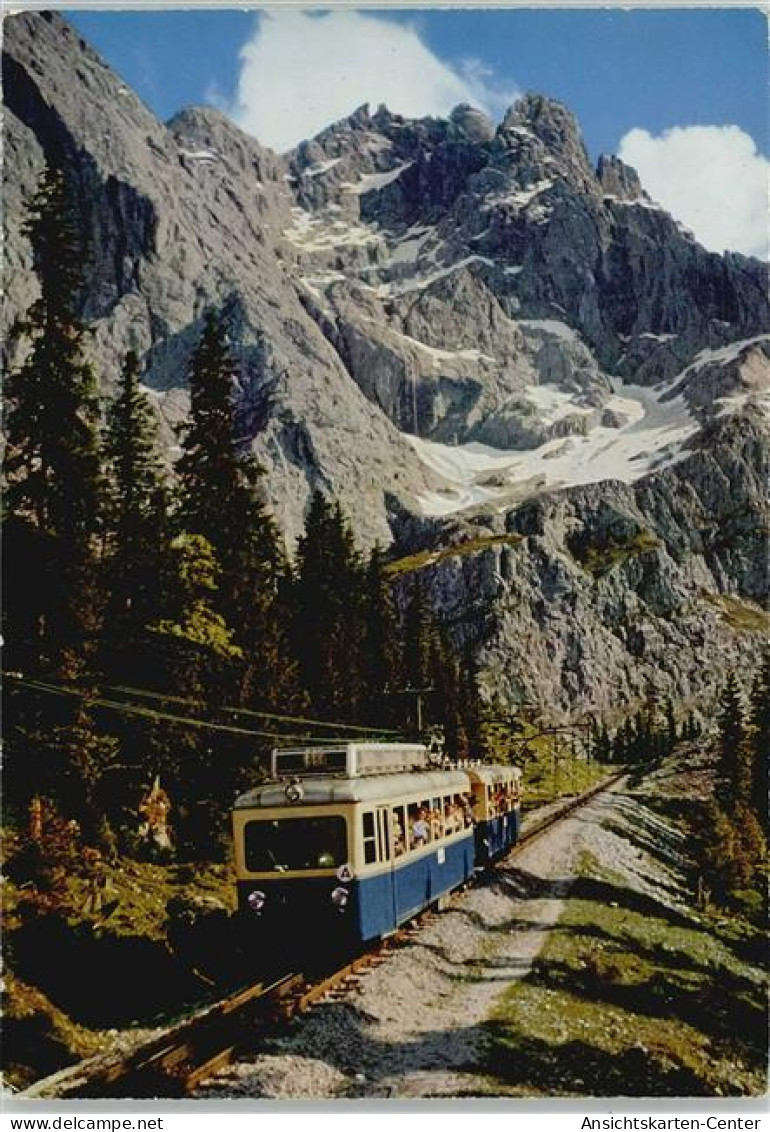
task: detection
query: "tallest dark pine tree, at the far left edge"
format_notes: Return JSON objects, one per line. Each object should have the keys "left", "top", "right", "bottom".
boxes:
{"left": 5, "top": 165, "right": 103, "bottom": 676}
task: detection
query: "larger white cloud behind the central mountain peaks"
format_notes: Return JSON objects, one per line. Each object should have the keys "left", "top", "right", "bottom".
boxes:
{"left": 224, "top": 11, "right": 517, "bottom": 152}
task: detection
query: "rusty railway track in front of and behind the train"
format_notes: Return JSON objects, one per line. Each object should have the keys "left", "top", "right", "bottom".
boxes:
{"left": 20, "top": 774, "right": 623, "bottom": 1099}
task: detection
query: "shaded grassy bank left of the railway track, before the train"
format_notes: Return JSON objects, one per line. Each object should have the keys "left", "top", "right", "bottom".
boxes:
{"left": 3, "top": 859, "right": 237, "bottom": 1088}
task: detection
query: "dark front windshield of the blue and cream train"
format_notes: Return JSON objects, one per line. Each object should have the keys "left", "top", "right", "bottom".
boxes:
{"left": 243, "top": 817, "right": 348, "bottom": 873}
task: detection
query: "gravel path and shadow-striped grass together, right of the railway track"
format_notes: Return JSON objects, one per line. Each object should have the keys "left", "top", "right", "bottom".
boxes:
{"left": 198, "top": 767, "right": 763, "bottom": 1098}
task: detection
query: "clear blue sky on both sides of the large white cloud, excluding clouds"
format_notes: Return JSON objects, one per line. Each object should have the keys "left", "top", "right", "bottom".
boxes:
{"left": 67, "top": 9, "right": 770, "bottom": 156}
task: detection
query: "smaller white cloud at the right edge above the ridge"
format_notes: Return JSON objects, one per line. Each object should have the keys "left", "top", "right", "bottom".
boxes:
{"left": 619, "top": 126, "right": 770, "bottom": 258}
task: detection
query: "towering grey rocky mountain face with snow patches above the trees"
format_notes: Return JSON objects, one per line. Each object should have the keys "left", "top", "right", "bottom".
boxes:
{"left": 3, "top": 12, "right": 770, "bottom": 712}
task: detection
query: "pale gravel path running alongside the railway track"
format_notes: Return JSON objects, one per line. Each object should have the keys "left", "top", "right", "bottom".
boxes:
{"left": 197, "top": 780, "right": 647, "bottom": 1098}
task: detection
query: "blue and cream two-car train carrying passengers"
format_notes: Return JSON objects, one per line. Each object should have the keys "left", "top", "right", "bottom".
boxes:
{"left": 232, "top": 743, "right": 521, "bottom": 952}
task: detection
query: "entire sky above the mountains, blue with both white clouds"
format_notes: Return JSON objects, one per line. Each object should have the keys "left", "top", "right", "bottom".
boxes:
{"left": 66, "top": 8, "right": 770, "bottom": 254}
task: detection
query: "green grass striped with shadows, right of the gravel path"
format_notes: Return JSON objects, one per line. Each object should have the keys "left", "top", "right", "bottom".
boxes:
{"left": 477, "top": 856, "right": 767, "bottom": 1097}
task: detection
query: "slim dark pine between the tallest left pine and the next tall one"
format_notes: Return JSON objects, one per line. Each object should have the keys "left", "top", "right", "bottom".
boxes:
{"left": 104, "top": 351, "right": 168, "bottom": 679}
